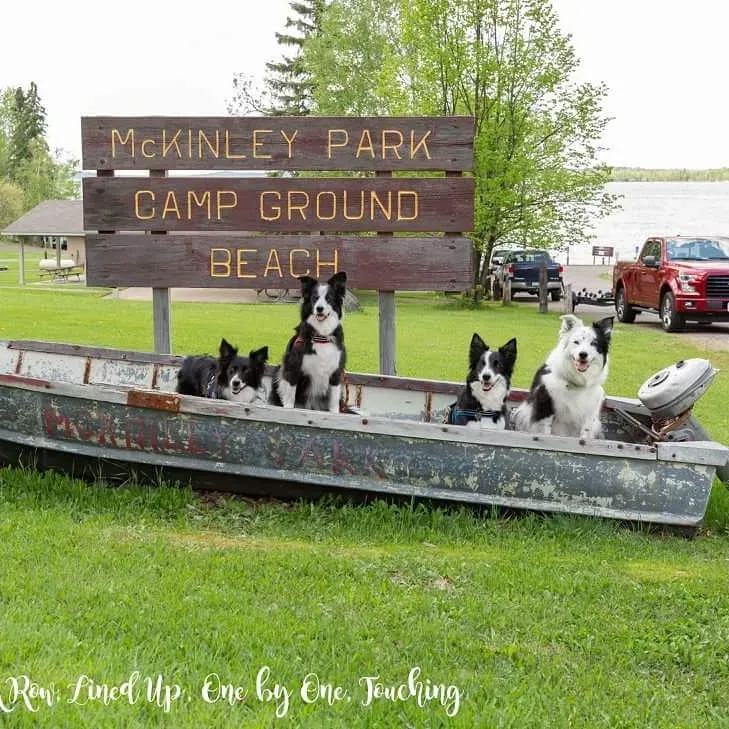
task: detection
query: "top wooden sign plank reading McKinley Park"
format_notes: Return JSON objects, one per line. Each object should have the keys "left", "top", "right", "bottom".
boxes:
{"left": 81, "top": 116, "right": 474, "bottom": 172}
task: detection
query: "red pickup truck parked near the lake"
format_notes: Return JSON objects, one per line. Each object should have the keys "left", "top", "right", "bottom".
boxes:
{"left": 613, "top": 236, "right": 729, "bottom": 332}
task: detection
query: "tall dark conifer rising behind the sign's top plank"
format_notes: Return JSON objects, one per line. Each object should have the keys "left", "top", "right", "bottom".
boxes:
{"left": 265, "top": 0, "right": 324, "bottom": 116}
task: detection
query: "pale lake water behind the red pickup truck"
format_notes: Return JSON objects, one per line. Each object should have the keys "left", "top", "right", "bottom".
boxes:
{"left": 557, "top": 182, "right": 729, "bottom": 264}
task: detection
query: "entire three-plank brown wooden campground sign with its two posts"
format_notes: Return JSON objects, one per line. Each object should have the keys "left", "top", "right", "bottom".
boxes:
{"left": 81, "top": 117, "right": 474, "bottom": 366}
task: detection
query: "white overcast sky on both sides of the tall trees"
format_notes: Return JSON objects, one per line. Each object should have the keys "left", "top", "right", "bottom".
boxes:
{"left": 0, "top": 0, "right": 729, "bottom": 168}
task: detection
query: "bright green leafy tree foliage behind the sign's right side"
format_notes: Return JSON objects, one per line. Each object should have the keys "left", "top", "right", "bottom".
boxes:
{"left": 303, "top": 0, "right": 616, "bottom": 291}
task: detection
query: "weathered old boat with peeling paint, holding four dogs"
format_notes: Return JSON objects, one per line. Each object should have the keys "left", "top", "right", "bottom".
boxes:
{"left": 0, "top": 341, "right": 729, "bottom": 527}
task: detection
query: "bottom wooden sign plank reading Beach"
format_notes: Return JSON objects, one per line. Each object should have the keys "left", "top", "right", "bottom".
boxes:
{"left": 86, "top": 233, "right": 472, "bottom": 291}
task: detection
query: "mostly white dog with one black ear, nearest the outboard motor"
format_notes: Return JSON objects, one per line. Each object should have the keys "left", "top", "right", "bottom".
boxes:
{"left": 513, "top": 314, "right": 613, "bottom": 438}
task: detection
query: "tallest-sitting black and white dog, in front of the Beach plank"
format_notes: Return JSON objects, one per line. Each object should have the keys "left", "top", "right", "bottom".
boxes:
{"left": 270, "top": 271, "right": 347, "bottom": 413}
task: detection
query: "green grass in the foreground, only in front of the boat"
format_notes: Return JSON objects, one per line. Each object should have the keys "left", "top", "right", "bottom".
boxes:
{"left": 0, "top": 470, "right": 729, "bottom": 729}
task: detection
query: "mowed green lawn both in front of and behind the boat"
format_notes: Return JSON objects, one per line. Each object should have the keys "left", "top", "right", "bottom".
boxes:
{"left": 0, "top": 276, "right": 729, "bottom": 729}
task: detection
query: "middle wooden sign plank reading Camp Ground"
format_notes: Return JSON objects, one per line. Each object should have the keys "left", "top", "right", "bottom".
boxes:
{"left": 83, "top": 177, "right": 474, "bottom": 232}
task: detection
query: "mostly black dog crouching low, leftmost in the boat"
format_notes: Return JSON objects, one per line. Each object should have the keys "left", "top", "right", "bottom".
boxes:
{"left": 177, "top": 339, "right": 268, "bottom": 403}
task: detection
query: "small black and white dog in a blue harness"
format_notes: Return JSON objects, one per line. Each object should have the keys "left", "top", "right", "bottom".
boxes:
{"left": 446, "top": 333, "right": 516, "bottom": 430}
